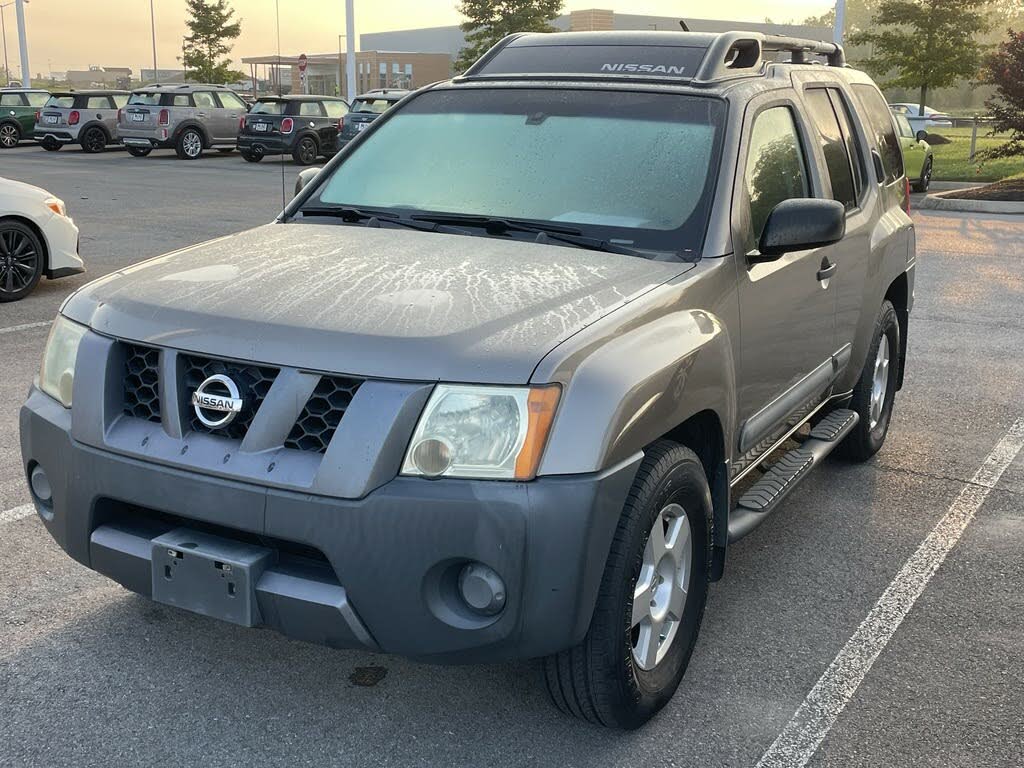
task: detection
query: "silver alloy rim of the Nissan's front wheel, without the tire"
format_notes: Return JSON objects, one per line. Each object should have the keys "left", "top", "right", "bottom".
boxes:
{"left": 630, "top": 504, "right": 693, "bottom": 670}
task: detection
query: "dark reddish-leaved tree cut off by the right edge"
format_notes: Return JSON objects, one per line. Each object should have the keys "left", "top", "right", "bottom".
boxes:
{"left": 980, "top": 30, "right": 1024, "bottom": 159}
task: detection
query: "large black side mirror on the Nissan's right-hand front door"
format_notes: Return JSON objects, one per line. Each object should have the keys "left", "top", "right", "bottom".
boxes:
{"left": 753, "top": 198, "right": 846, "bottom": 261}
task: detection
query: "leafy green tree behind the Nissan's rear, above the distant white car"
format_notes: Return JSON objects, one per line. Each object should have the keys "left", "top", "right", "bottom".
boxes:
{"left": 851, "top": 0, "right": 990, "bottom": 115}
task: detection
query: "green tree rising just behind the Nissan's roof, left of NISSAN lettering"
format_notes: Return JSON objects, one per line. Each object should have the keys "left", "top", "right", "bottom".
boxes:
{"left": 455, "top": 0, "right": 562, "bottom": 72}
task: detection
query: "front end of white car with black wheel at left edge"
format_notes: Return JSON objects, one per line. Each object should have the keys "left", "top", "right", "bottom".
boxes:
{"left": 0, "top": 177, "right": 85, "bottom": 302}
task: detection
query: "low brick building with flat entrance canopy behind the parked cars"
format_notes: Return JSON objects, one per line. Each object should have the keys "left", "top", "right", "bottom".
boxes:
{"left": 242, "top": 50, "right": 452, "bottom": 100}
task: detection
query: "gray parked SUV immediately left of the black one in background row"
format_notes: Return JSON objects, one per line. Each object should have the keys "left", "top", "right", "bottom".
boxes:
{"left": 118, "top": 83, "right": 249, "bottom": 160}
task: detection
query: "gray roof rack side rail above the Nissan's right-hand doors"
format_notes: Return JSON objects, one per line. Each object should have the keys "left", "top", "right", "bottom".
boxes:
{"left": 693, "top": 32, "right": 846, "bottom": 83}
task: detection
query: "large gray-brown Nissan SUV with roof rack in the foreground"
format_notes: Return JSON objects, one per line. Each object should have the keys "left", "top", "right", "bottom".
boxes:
{"left": 20, "top": 32, "right": 914, "bottom": 728}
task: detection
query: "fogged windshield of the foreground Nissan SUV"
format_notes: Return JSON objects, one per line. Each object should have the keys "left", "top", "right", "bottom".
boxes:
{"left": 315, "top": 89, "right": 725, "bottom": 252}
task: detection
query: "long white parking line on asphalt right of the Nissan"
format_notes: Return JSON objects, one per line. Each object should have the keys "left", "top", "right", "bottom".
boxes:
{"left": 757, "top": 418, "right": 1024, "bottom": 768}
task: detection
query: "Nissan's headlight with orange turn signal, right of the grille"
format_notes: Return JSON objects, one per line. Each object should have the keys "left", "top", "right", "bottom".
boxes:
{"left": 401, "top": 384, "right": 561, "bottom": 480}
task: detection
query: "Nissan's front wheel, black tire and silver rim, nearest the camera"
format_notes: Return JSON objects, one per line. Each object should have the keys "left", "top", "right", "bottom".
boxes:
{"left": 544, "top": 440, "right": 712, "bottom": 729}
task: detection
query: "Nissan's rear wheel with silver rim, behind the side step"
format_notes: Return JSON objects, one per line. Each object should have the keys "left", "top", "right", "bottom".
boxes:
{"left": 840, "top": 299, "right": 901, "bottom": 462}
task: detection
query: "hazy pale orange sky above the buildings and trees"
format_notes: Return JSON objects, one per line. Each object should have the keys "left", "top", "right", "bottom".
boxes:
{"left": 0, "top": 0, "right": 833, "bottom": 77}
